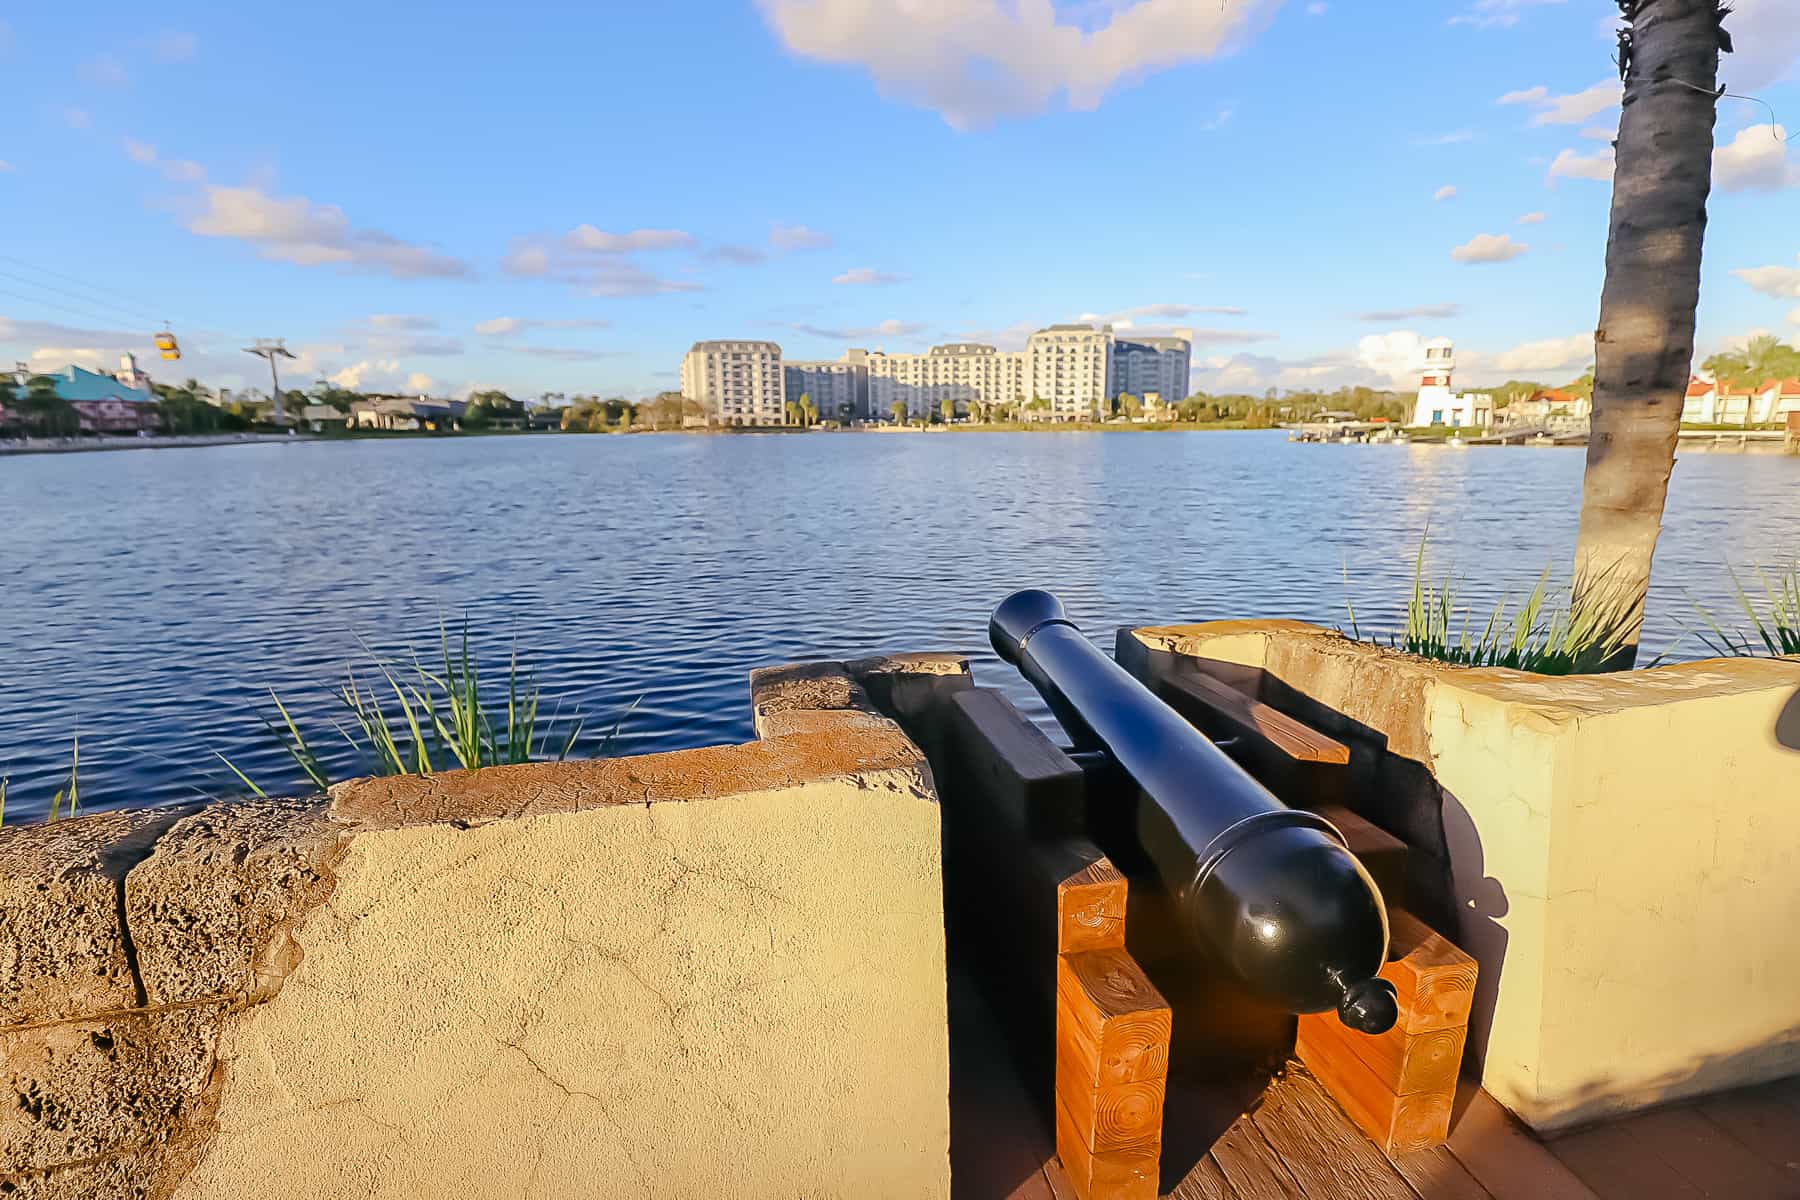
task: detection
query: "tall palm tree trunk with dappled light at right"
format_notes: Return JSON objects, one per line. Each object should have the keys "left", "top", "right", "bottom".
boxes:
{"left": 1575, "top": 0, "right": 1723, "bottom": 669}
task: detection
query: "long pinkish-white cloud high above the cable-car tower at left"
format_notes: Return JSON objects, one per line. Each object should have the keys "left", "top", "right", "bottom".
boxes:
{"left": 187, "top": 185, "right": 470, "bottom": 279}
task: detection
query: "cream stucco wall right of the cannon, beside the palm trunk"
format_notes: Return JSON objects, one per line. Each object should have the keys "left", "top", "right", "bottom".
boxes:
{"left": 1134, "top": 622, "right": 1800, "bottom": 1130}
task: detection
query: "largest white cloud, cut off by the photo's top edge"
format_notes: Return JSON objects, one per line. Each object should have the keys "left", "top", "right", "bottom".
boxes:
{"left": 760, "top": 0, "right": 1280, "bottom": 130}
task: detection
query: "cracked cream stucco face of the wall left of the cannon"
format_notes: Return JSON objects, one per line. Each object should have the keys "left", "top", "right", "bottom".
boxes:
{"left": 176, "top": 768, "right": 949, "bottom": 1200}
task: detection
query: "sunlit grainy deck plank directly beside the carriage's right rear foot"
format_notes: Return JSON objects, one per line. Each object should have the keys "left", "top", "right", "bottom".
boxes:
{"left": 1251, "top": 1065, "right": 1415, "bottom": 1200}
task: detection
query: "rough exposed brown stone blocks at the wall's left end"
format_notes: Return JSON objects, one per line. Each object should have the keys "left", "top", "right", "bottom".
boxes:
{"left": 0, "top": 797, "right": 342, "bottom": 1200}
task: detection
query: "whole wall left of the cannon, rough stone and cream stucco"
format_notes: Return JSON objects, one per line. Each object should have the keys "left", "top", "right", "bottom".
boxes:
{"left": 0, "top": 657, "right": 967, "bottom": 1200}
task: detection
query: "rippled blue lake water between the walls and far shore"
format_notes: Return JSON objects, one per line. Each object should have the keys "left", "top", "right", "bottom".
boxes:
{"left": 0, "top": 432, "right": 1800, "bottom": 820}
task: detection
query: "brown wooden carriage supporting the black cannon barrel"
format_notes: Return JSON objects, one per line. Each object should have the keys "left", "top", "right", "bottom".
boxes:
{"left": 907, "top": 597, "right": 1476, "bottom": 1200}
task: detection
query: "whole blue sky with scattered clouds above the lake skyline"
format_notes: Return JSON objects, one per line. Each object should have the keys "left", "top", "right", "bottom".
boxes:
{"left": 0, "top": 0, "right": 1800, "bottom": 396}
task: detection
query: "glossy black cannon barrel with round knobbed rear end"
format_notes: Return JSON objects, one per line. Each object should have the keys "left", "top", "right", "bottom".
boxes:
{"left": 988, "top": 588, "right": 1397, "bottom": 1033}
